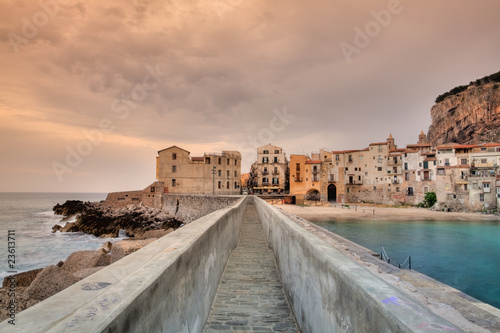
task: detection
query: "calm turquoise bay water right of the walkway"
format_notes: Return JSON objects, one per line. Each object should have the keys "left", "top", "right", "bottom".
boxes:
{"left": 315, "top": 221, "right": 500, "bottom": 308}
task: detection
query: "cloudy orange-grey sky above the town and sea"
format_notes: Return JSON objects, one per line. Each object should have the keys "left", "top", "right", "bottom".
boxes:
{"left": 0, "top": 0, "right": 500, "bottom": 192}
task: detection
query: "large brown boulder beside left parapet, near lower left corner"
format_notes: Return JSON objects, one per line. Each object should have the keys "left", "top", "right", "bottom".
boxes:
{"left": 24, "top": 265, "right": 78, "bottom": 301}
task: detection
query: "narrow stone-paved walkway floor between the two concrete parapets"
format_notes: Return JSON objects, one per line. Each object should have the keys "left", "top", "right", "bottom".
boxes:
{"left": 204, "top": 204, "right": 300, "bottom": 333}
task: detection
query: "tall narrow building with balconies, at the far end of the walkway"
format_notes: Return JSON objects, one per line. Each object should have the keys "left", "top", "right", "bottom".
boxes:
{"left": 252, "top": 144, "right": 288, "bottom": 194}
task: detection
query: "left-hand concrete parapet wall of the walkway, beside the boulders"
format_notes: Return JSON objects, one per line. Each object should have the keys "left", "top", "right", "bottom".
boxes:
{"left": 0, "top": 199, "right": 248, "bottom": 333}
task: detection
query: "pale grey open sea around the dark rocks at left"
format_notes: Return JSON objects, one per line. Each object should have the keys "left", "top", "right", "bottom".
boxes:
{"left": 0, "top": 193, "right": 125, "bottom": 282}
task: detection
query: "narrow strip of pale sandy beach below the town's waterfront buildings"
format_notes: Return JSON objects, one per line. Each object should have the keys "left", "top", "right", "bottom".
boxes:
{"left": 277, "top": 204, "right": 500, "bottom": 222}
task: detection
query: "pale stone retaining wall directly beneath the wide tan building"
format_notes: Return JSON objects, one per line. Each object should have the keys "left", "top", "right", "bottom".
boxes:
{"left": 162, "top": 194, "right": 241, "bottom": 222}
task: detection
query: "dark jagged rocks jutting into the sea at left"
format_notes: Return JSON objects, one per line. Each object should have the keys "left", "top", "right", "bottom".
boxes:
{"left": 52, "top": 200, "right": 183, "bottom": 237}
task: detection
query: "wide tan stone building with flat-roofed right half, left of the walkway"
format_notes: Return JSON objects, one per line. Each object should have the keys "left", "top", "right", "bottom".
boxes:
{"left": 156, "top": 146, "right": 241, "bottom": 195}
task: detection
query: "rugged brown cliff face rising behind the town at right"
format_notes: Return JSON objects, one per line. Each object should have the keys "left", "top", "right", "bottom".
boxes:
{"left": 427, "top": 83, "right": 500, "bottom": 146}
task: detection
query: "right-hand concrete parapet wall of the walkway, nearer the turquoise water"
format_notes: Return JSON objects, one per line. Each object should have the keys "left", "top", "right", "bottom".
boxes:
{"left": 254, "top": 198, "right": 461, "bottom": 333}
